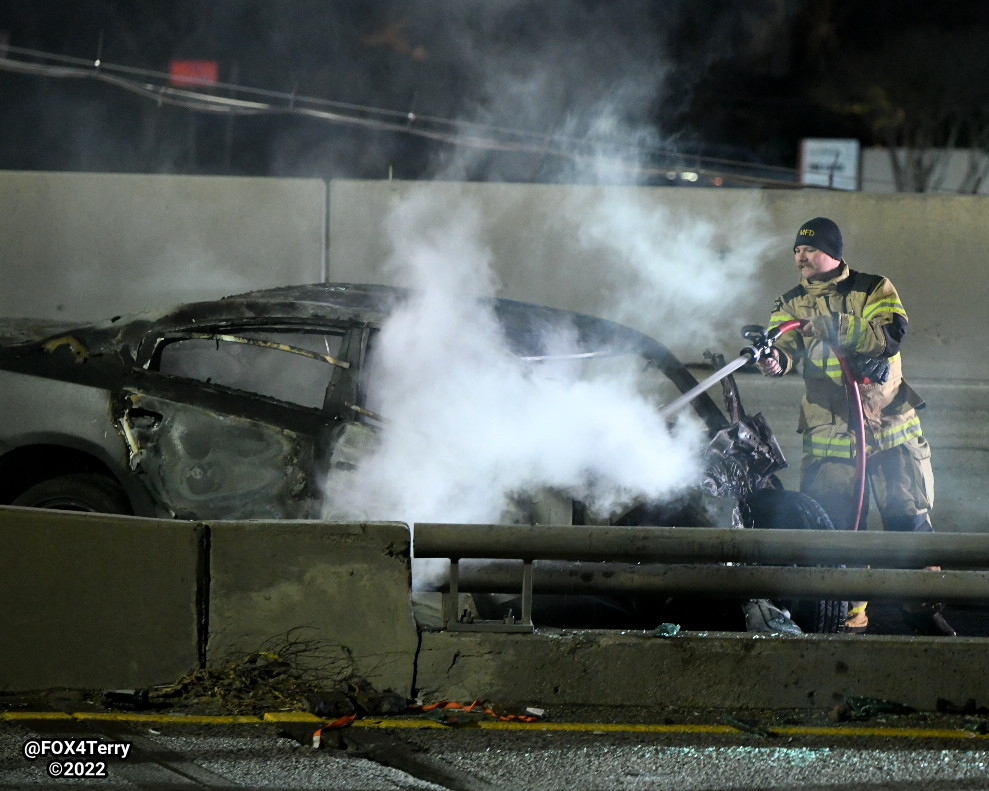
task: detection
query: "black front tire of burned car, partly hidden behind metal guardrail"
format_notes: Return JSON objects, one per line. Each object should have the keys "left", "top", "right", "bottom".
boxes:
{"left": 747, "top": 489, "right": 848, "bottom": 634}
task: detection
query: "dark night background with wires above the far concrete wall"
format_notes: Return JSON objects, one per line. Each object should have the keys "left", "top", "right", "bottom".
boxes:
{"left": 0, "top": 0, "right": 989, "bottom": 183}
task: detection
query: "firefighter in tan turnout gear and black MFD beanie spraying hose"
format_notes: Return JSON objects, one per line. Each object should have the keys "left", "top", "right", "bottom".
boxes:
{"left": 758, "top": 217, "right": 955, "bottom": 637}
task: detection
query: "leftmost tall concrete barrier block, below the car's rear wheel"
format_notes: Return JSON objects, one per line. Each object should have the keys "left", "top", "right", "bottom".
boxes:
{"left": 0, "top": 506, "right": 206, "bottom": 691}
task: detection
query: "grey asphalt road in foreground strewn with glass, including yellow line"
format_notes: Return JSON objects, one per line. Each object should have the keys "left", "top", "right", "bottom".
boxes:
{"left": 0, "top": 712, "right": 989, "bottom": 791}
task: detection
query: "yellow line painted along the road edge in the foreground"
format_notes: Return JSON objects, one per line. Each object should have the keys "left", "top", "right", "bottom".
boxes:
{"left": 0, "top": 711, "right": 986, "bottom": 739}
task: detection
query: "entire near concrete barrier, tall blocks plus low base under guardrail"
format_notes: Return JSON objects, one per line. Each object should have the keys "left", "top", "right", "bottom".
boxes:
{"left": 7, "top": 507, "right": 989, "bottom": 710}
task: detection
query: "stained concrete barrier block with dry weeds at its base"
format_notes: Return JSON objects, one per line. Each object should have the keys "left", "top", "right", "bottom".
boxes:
{"left": 208, "top": 522, "right": 418, "bottom": 696}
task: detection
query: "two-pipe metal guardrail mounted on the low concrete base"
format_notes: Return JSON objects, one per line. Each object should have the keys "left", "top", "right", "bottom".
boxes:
{"left": 413, "top": 523, "right": 989, "bottom": 631}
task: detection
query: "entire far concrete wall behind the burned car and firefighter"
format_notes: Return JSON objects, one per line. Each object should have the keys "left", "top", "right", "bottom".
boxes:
{"left": 0, "top": 171, "right": 989, "bottom": 382}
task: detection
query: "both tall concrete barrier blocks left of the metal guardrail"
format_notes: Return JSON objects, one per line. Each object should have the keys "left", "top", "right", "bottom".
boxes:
{"left": 0, "top": 507, "right": 418, "bottom": 696}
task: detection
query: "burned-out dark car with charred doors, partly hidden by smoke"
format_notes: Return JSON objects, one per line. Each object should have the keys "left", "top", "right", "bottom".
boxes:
{"left": 0, "top": 283, "right": 831, "bottom": 629}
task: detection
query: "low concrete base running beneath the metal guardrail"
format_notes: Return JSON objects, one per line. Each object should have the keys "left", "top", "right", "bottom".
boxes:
{"left": 416, "top": 632, "right": 989, "bottom": 711}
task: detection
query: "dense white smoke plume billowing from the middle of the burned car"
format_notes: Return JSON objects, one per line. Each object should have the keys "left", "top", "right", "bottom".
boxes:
{"left": 327, "top": 190, "right": 703, "bottom": 588}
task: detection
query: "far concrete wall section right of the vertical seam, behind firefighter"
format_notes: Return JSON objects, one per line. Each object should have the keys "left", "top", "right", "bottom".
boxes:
{"left": 329, "top": 181, "right": 989, "bottom": 383}
